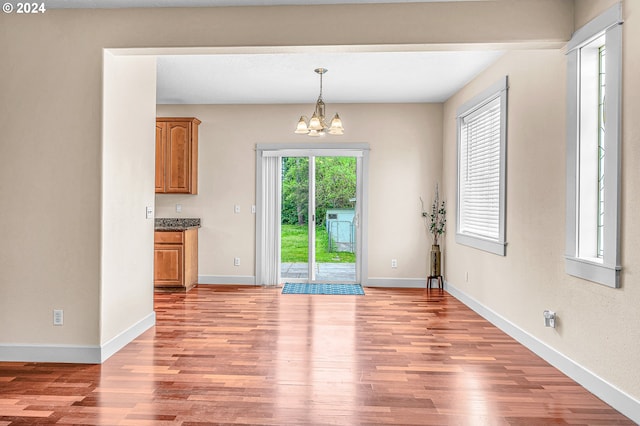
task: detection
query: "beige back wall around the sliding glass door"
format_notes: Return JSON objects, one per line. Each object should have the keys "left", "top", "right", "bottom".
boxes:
{"left": 156, "top": 104, "right": 442, "bottom": 282}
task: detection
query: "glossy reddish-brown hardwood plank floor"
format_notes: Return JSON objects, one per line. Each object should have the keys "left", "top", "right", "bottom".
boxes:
{"left": 0, "top": 286, "right": 633, "bottom": 426}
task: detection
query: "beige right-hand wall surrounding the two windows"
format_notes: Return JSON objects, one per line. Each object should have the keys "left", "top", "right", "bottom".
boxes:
{"left": 443, "top": 2, "right": 640, "bottom": 406}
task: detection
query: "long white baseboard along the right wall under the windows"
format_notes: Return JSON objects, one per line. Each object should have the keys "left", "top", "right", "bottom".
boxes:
{"left": 445, "top": 281, "right": 640, "bottom": 424}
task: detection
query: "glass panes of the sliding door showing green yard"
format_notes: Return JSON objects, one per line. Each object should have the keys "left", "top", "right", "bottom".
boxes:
{"left": 280, "top": 152, "right": 362, "bottom": 283}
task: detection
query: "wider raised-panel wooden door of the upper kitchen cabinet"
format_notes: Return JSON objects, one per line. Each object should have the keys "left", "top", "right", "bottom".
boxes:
{"left": 165, "top": 122, "right": 191, "bottom": 193}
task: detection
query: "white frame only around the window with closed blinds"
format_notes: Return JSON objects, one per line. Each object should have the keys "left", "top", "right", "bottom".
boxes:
{"left": 456, "top": 76, "right": 509, "bottom": 256}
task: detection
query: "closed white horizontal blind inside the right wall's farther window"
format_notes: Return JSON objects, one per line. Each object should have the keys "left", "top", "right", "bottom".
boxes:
{"left": 460, "top": 97, "right": 501, "bottom": 241}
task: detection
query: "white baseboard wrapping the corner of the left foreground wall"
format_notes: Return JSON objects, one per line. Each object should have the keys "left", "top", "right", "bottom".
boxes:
{"left": 0, "top": 312, "right": 156, "bottom": 364}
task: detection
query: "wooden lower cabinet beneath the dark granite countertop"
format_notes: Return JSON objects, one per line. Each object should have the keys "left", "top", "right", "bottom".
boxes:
{"left": 153, "top": 228, "right": 198, "bottom": 290}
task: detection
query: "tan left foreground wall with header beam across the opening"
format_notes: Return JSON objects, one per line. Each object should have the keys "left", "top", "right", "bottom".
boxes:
{"left": 0, "top": 0, "right": 573, "bottom": 354}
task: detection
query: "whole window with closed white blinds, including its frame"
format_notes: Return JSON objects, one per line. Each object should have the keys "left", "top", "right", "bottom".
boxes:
{"left": 456, "top": 77, "right": 508, "bottom": 256}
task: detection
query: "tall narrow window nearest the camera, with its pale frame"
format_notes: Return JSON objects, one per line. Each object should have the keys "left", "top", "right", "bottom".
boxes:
{"left": 566, "top": 4, "right": 622, "bottom": 287}
